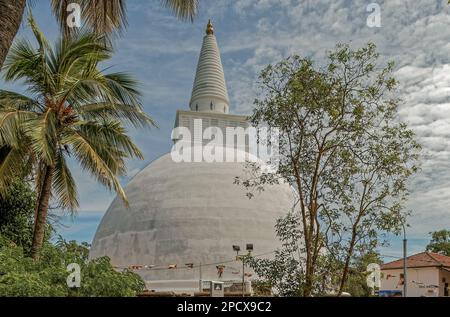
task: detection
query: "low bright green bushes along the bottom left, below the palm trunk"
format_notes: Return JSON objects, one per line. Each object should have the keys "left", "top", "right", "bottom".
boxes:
{"left": 0, "top": 236, "right": 145, "bottom": 297}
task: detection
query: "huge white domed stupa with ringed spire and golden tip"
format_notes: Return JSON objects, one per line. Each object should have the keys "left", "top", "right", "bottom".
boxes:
{"left": 90, "top": 22, "right": 293, "bottom": 292}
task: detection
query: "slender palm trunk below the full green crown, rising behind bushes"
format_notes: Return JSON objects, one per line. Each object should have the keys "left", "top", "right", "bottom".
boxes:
{"left": 31, "top": 166, "right": 55, "bottom": 260}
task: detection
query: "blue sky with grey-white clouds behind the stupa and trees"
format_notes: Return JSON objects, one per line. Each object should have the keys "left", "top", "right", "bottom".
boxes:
{"left": 0, "top": 0, "right": 450, "bottom": 255}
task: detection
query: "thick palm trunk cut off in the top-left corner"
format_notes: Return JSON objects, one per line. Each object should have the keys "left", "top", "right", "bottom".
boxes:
{"left": 0, "top": 0, "right": 26, "bottom": 70}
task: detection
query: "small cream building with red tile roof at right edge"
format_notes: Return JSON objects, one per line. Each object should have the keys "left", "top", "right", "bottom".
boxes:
{"left": 380, "top": 252, "right": 450, "bottom": 297}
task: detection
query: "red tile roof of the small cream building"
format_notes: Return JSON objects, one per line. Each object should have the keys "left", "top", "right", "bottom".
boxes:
{"left": 381, "top": 252, "right": 450, "bottom": 270}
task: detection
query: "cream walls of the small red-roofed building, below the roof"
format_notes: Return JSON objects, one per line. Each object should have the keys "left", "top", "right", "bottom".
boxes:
{"left": 380, "top": 267, "right": 440, "bottom": 297}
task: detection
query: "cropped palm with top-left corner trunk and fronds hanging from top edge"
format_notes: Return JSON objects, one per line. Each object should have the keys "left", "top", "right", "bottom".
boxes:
{"left": 0, "top": 0, "right": 199, "bottom": 69}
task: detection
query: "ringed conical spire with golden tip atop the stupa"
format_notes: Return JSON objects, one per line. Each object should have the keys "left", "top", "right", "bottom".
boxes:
{"left": 189, "top": 20, "right": 230, "bottom": 113}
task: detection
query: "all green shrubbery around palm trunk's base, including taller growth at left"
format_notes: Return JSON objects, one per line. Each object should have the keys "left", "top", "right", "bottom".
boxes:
{"left": 0, "top": 180, "right": 144, "bottom": 296}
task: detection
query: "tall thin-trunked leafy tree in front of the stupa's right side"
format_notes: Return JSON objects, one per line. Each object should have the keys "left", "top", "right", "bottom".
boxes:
{"left": 237, "top": 44, "right": 420, "bottom": 296}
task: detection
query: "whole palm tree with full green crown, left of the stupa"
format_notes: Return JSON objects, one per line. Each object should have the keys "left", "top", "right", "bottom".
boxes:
{"left": 0, "top": 13, "right": 154, "bottom": 259}
